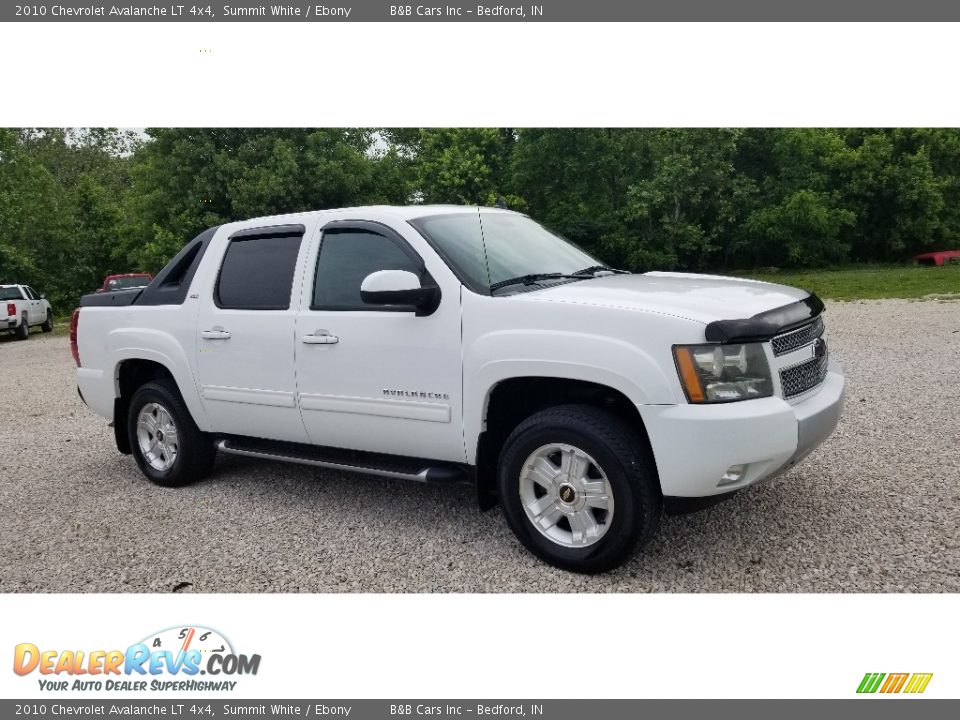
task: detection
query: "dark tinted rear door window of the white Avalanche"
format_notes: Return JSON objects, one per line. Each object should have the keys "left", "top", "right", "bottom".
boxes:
{"left": 216, "top": 236, "right": 301, "bottom": 310}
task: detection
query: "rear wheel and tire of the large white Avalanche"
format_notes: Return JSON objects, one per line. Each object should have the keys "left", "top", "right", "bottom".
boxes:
{"left": 127, "top": 380, "right": 217, "bottom": 487}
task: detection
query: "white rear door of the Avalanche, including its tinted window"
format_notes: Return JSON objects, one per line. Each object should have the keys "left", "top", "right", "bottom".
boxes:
{"left": 197, "top": 225, "right": 306, "bottom": 442}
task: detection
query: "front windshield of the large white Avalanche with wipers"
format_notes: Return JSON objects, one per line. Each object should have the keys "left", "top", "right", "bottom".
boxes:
{"left": 411, "top": 212, "right": 601, "bottom": 293}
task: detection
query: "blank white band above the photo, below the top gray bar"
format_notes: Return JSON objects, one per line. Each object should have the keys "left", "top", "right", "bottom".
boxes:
{"left": 0, "top": 22, "right": 960, "bottom": 127}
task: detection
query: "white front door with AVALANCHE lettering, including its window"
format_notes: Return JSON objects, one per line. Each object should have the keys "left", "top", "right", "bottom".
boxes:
{"left": 295, "top": 222, "right": 464, "bottom": 462}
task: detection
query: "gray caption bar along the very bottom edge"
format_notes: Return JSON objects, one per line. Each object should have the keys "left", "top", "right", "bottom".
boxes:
{"left": 0, "top": 696, "right": 960, "bottom": 720}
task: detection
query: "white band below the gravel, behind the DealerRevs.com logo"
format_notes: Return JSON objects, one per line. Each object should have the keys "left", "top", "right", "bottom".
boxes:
{"left": 0, "top": 594, "right": 960, "bottom": 702}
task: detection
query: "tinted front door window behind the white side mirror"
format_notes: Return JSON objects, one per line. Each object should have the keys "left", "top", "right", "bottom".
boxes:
{"left": 311, "top": 230, "right": 421, "bottom": 310}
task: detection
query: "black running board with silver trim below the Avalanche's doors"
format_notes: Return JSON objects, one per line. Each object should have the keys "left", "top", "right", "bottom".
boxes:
{"left": 216, "top": 439, "right": 469, "bottom": 483}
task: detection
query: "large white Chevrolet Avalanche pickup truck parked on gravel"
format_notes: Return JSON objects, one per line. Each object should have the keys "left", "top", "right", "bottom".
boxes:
{"left": 71, "top": 206, "right": 844, "bottom": 572}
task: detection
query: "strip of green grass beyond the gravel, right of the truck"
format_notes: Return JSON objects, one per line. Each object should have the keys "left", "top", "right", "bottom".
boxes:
{"left": 742, "top": 264, "right": 960, "bottom": 300}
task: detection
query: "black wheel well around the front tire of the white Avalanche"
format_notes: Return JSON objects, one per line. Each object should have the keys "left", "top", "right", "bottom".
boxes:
{"left": 476, "top": 377, "right": 653, "bottom": 510}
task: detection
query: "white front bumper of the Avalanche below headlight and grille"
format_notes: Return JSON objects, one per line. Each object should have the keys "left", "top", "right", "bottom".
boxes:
{"left": 639, "top": 361, "right": 844, "bottom": 498}
